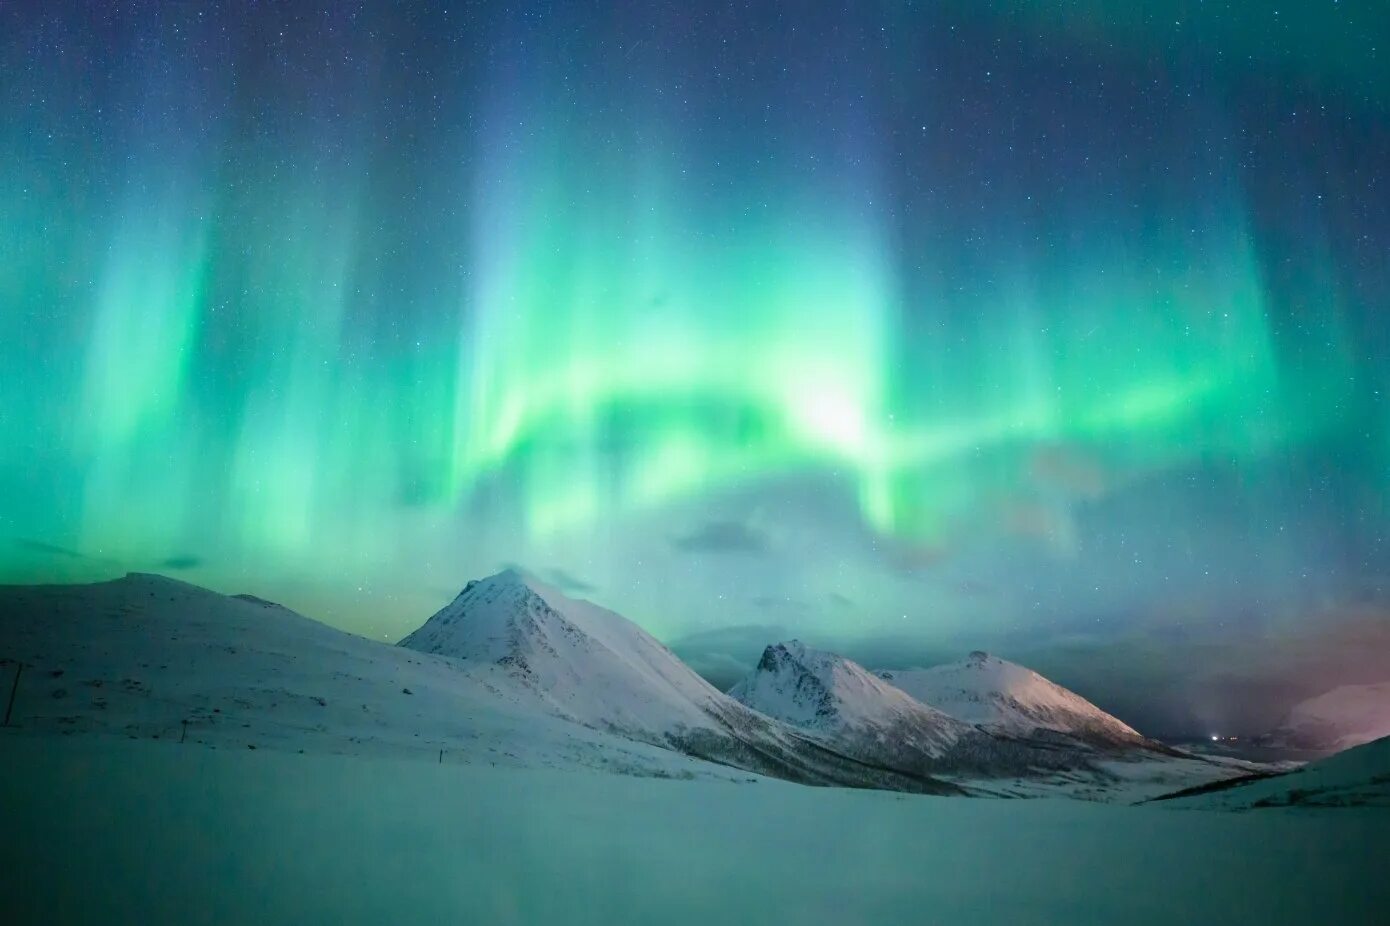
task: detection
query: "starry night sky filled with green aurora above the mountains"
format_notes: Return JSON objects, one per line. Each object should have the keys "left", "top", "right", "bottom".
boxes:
{"left": 0, "top": 0, "right": 1390, "bottom": 733}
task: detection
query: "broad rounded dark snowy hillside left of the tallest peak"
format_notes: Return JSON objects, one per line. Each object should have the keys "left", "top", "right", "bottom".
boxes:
{"left": 0, "top": 574, "right": 746, "bottom": 777}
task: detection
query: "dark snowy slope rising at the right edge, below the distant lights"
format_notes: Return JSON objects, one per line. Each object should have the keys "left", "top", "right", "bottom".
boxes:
{"left": 1165, "top": 737, "right": 1390, "bottom": 809}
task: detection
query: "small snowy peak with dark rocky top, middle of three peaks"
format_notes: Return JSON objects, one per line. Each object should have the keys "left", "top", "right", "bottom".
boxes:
{"left": 728, "top": 640, "right": 973, "bottom": 759}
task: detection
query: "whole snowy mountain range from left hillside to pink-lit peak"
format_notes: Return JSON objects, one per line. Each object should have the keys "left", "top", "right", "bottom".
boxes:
{"left": 0, "top": 570, "right": 1273, "bottom": 801}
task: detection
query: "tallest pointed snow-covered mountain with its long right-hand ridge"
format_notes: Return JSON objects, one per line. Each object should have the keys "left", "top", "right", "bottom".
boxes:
{"left": 400, "top": 570, "right": 954, "bottom": 791}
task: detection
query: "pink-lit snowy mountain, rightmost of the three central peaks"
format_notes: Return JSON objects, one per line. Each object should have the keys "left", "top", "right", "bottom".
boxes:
{"left": 878, "top": 651, "right": 1147, "bottom": 747}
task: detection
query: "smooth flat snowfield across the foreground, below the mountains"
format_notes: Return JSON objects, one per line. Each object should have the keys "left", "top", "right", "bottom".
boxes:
{"left": 0, "top": 731, "right": 1390, "bottom": 926}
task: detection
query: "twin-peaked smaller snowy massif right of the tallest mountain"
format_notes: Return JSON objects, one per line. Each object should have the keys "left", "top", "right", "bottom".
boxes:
{"left": 730, "top": 641, "right": 1239, "bottom": 801}
